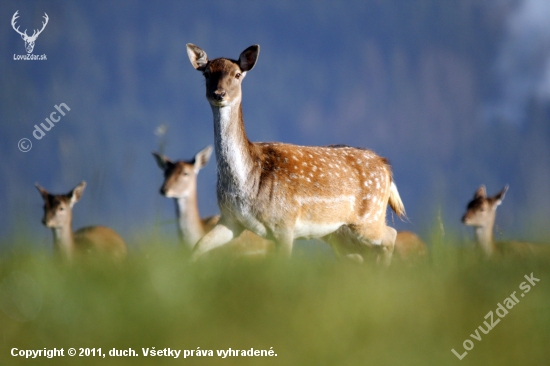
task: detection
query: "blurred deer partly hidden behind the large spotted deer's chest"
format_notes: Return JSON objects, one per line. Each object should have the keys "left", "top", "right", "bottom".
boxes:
{"left": 153, "top": 146, "right": 272, "bottom": 256}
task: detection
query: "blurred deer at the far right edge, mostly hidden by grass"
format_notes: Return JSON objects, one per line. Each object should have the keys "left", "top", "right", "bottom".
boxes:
{"left": 462, "top": 185, "right": 550, "bottom": 257}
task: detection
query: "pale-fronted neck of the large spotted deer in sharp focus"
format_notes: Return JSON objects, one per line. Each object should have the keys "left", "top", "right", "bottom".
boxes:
{"left": 212, "top": 101, "right": 254, "bottom": 194}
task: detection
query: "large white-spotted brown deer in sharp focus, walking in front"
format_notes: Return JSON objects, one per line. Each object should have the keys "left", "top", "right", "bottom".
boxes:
{"left": 187, "top": 44, "right": 405, "bottom": 264}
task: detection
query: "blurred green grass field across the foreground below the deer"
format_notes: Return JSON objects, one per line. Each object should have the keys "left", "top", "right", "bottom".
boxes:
{"left": 0, "top": 234, "right": 550, "bottom": 366}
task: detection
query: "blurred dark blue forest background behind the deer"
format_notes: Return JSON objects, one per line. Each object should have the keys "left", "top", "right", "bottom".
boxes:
{"left": 0, "top": 0, "right": 550, "bottom": 247}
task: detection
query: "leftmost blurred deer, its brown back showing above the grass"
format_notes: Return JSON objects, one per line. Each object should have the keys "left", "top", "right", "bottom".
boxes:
{"left": 36, "top": 182, "right": 127, "bottom": 261}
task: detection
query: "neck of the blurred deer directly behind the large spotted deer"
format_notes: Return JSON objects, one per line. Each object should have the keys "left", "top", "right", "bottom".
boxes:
{"left": 174, "top": 194, "right": 204, "bottom": 249}
